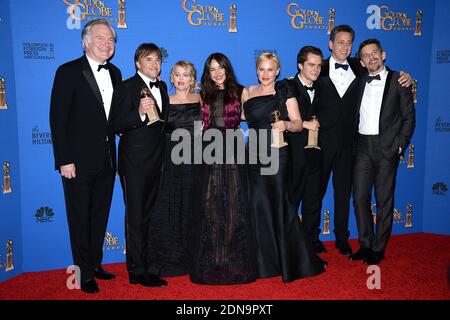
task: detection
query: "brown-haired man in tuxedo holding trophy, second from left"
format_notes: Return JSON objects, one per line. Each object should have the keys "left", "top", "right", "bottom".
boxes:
{"left": 112, "top": 43, "right": 169, "bottom": 286}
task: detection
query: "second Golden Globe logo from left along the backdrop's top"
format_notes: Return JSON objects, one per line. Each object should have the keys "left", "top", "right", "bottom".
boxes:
{"left": 182, "top": 0, "right": 227, "bottom": 27}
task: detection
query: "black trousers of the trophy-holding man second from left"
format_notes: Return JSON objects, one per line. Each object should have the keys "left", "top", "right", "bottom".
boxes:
{"left": 120, "top": 169, "right": 160, "bottom": 276}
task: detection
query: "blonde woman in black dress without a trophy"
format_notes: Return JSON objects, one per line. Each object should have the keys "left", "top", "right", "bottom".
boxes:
{"left": 149, "top": 61, "right": 200, "bottom": 276}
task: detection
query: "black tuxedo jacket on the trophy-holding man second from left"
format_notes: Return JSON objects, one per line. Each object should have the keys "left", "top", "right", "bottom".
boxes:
{"left": 112, "top": 74, "right": 169, "bottom": 176}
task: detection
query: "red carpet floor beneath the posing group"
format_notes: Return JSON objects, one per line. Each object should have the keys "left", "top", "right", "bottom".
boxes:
{"left": 0, "top": 233, "right": 450, "bottom": 300}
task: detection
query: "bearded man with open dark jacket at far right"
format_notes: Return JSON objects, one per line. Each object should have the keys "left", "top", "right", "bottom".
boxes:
{"left": 350, "top": 39, "right": 415, "bottom": 264}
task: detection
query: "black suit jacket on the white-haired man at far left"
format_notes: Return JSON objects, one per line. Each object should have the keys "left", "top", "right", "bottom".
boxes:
{"left": 50, "top": 56, "right": 122, "bottom": 174}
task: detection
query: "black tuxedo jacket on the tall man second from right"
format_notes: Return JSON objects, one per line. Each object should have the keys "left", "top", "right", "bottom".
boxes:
{"left": 315, "top": 58, "right": 367, "bottom": 150}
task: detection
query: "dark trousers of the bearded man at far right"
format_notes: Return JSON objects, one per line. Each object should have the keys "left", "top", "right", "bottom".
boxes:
{"left": 353, "top": 135, "right": 398, "bottom": 252}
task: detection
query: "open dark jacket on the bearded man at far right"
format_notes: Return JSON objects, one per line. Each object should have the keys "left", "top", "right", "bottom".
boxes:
{"left": 356, "top": 67, "right": 416, "bottom": 160}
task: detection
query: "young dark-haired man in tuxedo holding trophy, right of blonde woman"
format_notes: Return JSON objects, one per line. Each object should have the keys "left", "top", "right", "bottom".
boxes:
{"left": 288, "top": 46, "right": 326, "bottom": 253}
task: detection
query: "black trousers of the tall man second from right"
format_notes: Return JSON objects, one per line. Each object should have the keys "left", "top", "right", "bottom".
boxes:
{"left": 321, "top": 146, "right": 352, "bottom": 241}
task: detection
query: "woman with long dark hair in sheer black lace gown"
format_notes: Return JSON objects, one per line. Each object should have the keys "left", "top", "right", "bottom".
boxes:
{"left": 190, "top": 53, "right": 256, "bottom": 284}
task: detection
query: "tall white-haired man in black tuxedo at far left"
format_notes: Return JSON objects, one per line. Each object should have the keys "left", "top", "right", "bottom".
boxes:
{"left": 50, "top": 19, "right": 122, "bottom": 293}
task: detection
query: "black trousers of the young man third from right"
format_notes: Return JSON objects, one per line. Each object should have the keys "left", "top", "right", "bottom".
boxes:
{"left": 292, "top": 149, "right": 323, "bottom": 243}
